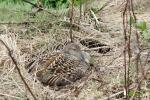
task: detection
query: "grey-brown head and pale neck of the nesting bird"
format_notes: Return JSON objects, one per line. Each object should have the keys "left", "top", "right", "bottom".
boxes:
{"left": 64, "top": 43, "right": 91, "bottom": 63}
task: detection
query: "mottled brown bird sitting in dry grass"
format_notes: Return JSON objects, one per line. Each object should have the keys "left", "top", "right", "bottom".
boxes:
{"left": 27, "top": 43, "right": 91, "bottom": 88}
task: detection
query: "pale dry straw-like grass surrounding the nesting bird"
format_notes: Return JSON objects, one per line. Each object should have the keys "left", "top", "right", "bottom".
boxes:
{"left": 0, "top": 0, "right": 150, "bottom": 100}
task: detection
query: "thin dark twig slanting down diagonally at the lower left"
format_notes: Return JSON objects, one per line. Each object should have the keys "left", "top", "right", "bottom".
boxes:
{"left": 0, "top": 40, "right": 37, "bottom": 100}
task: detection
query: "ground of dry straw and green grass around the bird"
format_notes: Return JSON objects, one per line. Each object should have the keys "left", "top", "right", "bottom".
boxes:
{"left": 0, "top": 0, "right": 150, "bottom": 100}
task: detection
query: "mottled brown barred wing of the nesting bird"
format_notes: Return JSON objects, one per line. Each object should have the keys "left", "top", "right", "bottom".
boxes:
{"left": 36, "top": 53, "right": 86, "bottom": 85}
